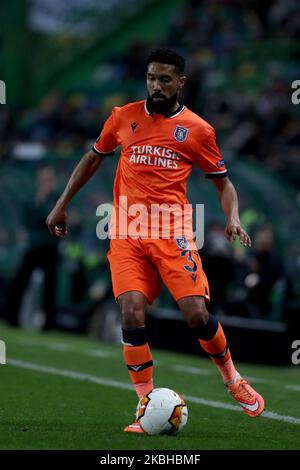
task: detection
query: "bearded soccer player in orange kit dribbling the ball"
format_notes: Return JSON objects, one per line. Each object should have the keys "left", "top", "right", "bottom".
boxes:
{"left": 47, "top": 49, "right": 264, "bottom": 433}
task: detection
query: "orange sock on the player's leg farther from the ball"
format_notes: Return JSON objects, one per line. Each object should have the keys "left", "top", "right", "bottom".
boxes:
{"left": 199, "top": 322, "right": 237, "bottom": 384}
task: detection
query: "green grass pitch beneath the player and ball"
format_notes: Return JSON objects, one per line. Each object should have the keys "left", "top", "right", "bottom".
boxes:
{"left": 0, "top": 324, "right": 300, "bottom": 450}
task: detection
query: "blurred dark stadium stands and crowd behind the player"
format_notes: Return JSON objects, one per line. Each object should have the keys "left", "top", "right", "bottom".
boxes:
{"left": 0, "top": 0, "right": 300, "bottom": 364}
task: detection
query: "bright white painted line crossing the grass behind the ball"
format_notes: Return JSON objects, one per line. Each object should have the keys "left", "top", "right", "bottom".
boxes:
{"left": 7, "top": 359, "right": 300, "bottom": 425}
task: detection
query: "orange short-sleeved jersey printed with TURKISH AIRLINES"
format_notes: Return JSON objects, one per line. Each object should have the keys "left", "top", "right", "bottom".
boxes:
{"left": 93, "top": 100, "right": 227, "bottom": 238}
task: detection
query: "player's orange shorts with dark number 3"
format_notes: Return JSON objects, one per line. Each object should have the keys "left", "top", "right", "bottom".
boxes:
{"left": 107, "top": 238, "right": 209, "bottom": 304}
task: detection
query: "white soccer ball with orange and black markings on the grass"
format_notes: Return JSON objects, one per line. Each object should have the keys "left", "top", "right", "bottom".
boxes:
{"left": 136, "top": 388, "right": 188, "bottom": 434}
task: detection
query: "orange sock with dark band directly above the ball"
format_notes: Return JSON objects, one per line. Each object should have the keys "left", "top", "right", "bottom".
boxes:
{"left": 123, "top": 343, "right": 154, "bottom": 398}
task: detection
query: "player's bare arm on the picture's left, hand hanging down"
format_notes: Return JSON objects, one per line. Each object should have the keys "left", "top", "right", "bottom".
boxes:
{"left": 46, "top": 150, "right": 105, "bottom": 238}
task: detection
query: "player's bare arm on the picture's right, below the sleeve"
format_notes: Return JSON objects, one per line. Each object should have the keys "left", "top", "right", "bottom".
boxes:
{"left": 212, "top": 176, "right": 251, "bottom": 246}
